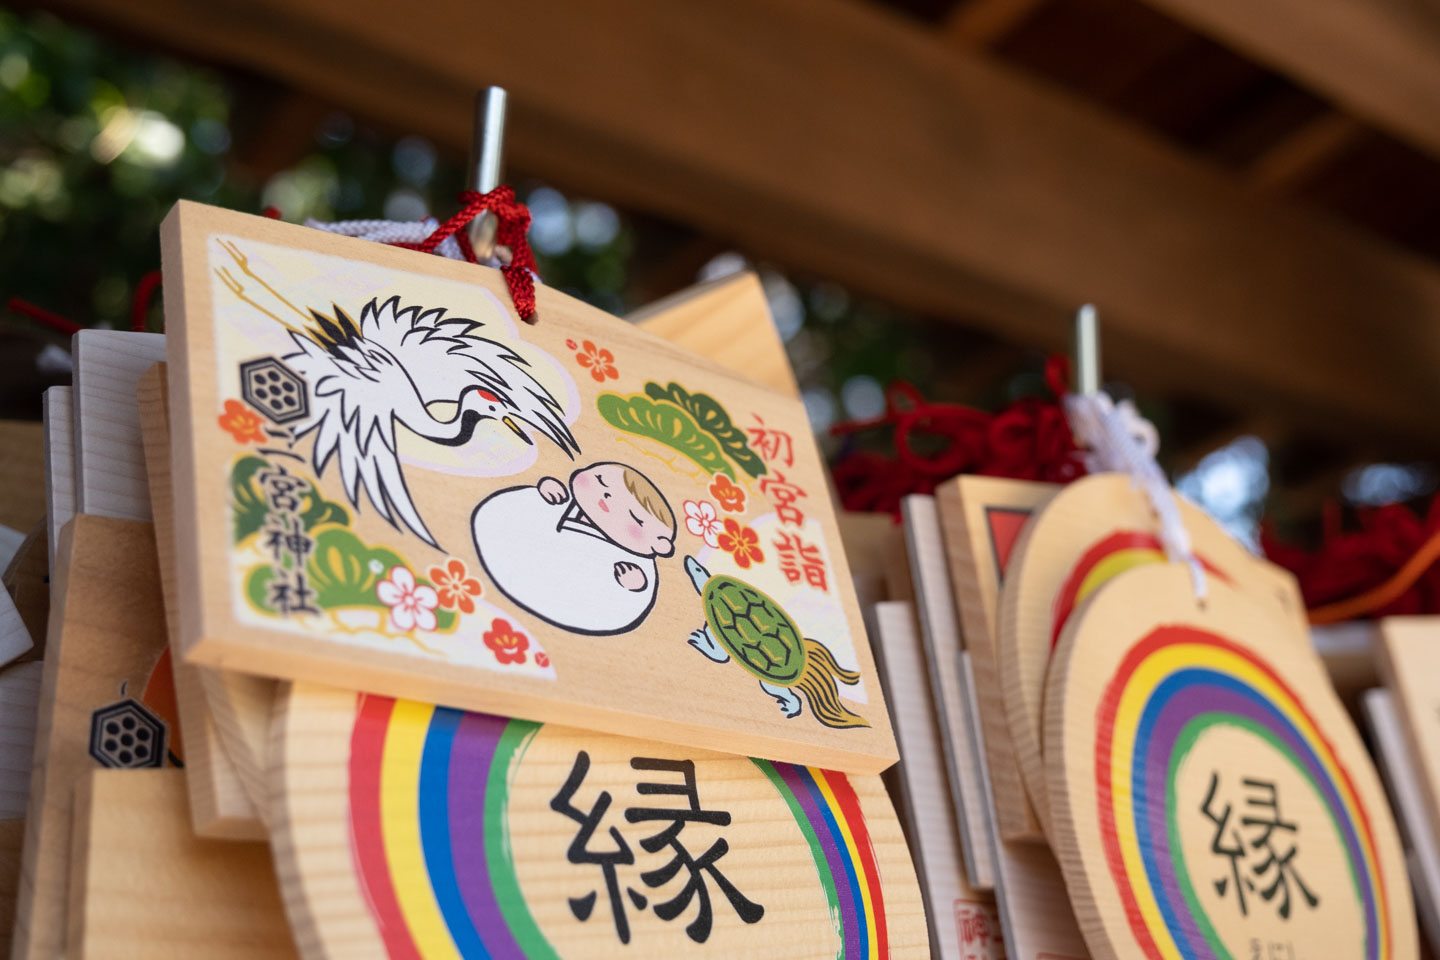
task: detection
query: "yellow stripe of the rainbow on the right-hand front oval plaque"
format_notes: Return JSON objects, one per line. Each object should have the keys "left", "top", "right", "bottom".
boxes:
{"left": 1110, "top": 643, "right": 1390, "bottom": 960}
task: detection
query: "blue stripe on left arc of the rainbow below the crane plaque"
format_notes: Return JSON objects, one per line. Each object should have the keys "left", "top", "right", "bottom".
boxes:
{"left": 420, "top": 707, "right": 490, "bottom": 960}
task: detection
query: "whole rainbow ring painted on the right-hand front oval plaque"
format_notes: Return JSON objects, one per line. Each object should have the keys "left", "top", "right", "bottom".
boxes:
{"left": 1094, "top": 626, "right": 1391, "bottom": 960}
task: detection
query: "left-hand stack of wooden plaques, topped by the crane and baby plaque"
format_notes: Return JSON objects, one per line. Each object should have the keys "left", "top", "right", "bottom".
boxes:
{"left": 0, "top": 204, "right": 929, "bottom": 960}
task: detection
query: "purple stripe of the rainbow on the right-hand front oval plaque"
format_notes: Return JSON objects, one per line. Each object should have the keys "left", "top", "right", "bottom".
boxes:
{"left": 1136, "top": 678, "right": 1378, "bottom": 957}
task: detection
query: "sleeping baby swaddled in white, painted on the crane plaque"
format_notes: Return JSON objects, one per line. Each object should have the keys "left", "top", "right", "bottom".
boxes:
{"left": 471, "top": 463, "right": 675, "bottom": 635}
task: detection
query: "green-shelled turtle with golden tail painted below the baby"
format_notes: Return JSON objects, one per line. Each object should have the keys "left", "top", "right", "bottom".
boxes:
{"left": 685, "top": 557, "right": 870, "bottom": 727}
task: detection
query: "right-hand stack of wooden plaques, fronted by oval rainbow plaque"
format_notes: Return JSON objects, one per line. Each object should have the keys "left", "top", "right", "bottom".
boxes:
{"left": 846, "top": 475, "right": 1437, "bottom": 960}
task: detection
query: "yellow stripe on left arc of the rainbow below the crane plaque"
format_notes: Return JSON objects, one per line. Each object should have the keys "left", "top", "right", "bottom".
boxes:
{"left": 380, "top": 699, "right": 461, "bottom": 960}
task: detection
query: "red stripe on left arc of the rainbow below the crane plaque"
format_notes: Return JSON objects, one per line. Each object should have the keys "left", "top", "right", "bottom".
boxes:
{"left": 350, "top": 694, "right": 422, "bottom": 960}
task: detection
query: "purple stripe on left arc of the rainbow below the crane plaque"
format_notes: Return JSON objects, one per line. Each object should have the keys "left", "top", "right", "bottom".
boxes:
{"left": 448, "top": 712, "right": 526, "bottom": 960}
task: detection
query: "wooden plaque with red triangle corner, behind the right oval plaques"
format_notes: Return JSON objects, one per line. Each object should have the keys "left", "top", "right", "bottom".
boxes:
{"left": 935, "top": 476, "right": 1060, "bottom": 841}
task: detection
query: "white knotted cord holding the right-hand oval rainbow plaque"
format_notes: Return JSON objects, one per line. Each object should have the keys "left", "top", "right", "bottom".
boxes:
{"left": 1064, "top": 391, "right": 1205, "bottom": 600}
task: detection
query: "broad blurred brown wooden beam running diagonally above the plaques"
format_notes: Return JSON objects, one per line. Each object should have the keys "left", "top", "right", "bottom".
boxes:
{"left": 42, "top": 0, "right": 1440, "bottom": 446}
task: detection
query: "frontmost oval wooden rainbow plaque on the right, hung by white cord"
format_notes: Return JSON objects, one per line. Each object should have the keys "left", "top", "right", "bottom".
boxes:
{"left": 1045, "top": 564, "right": 1418, "bottom": 960}
